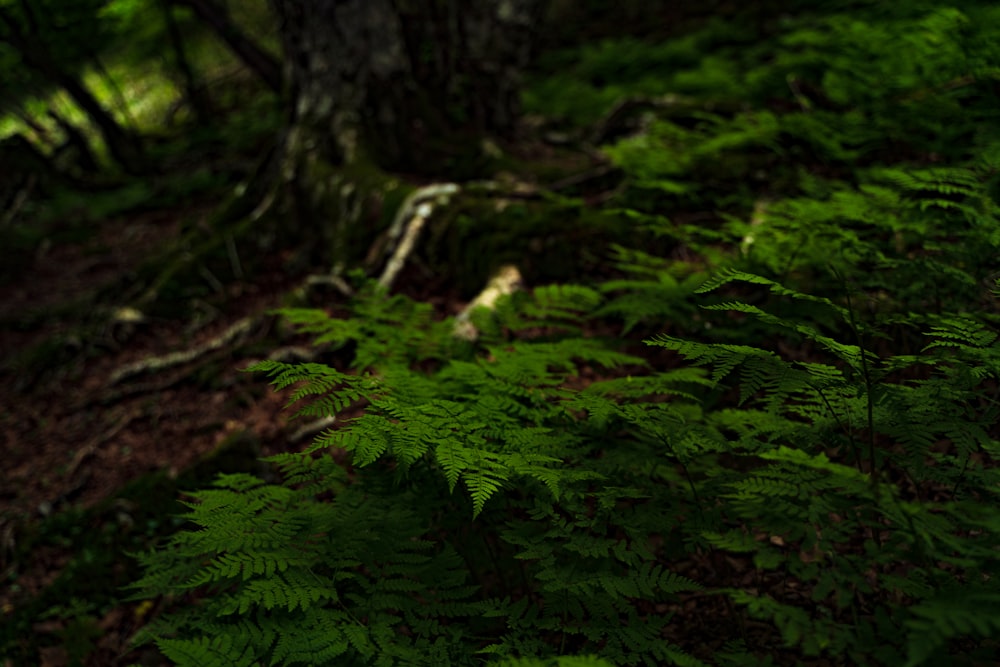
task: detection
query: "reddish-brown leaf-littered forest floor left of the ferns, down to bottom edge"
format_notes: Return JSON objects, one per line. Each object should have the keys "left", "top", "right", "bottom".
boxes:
{"left": 0, "top": 192, "right": 424, "bottom": 667}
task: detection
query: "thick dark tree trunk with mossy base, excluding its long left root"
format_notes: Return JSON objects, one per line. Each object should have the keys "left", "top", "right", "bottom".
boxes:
{"left": 273, "top": 0, "right": 544, "bottom": 264}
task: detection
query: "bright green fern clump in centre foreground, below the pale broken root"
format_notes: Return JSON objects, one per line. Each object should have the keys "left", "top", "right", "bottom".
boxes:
{"left": 136, "top": 287, "right": 720, "bottom": 665}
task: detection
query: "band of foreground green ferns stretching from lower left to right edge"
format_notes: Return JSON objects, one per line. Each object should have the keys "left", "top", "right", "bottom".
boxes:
{"left": 137, "top": 253, "right": 1000, "bottom": 665}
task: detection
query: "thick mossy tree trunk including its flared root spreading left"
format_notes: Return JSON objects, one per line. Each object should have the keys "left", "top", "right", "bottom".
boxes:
{"left": 133, "top": 0, "right": 548, "bottom": 303}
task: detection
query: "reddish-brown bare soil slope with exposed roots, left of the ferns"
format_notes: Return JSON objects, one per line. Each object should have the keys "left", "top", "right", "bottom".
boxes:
{"left": 0, "top": 204, "right": 291, "bottom": 517}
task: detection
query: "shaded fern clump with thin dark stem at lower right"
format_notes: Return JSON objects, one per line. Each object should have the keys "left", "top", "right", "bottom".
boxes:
{"left": 651, "top": 271, "right": 1000, "bottom": 665}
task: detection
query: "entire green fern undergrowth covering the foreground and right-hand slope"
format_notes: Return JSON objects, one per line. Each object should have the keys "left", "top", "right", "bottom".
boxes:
{"left": 135, "top": 3, "right": 1000, "bottom": 667}
